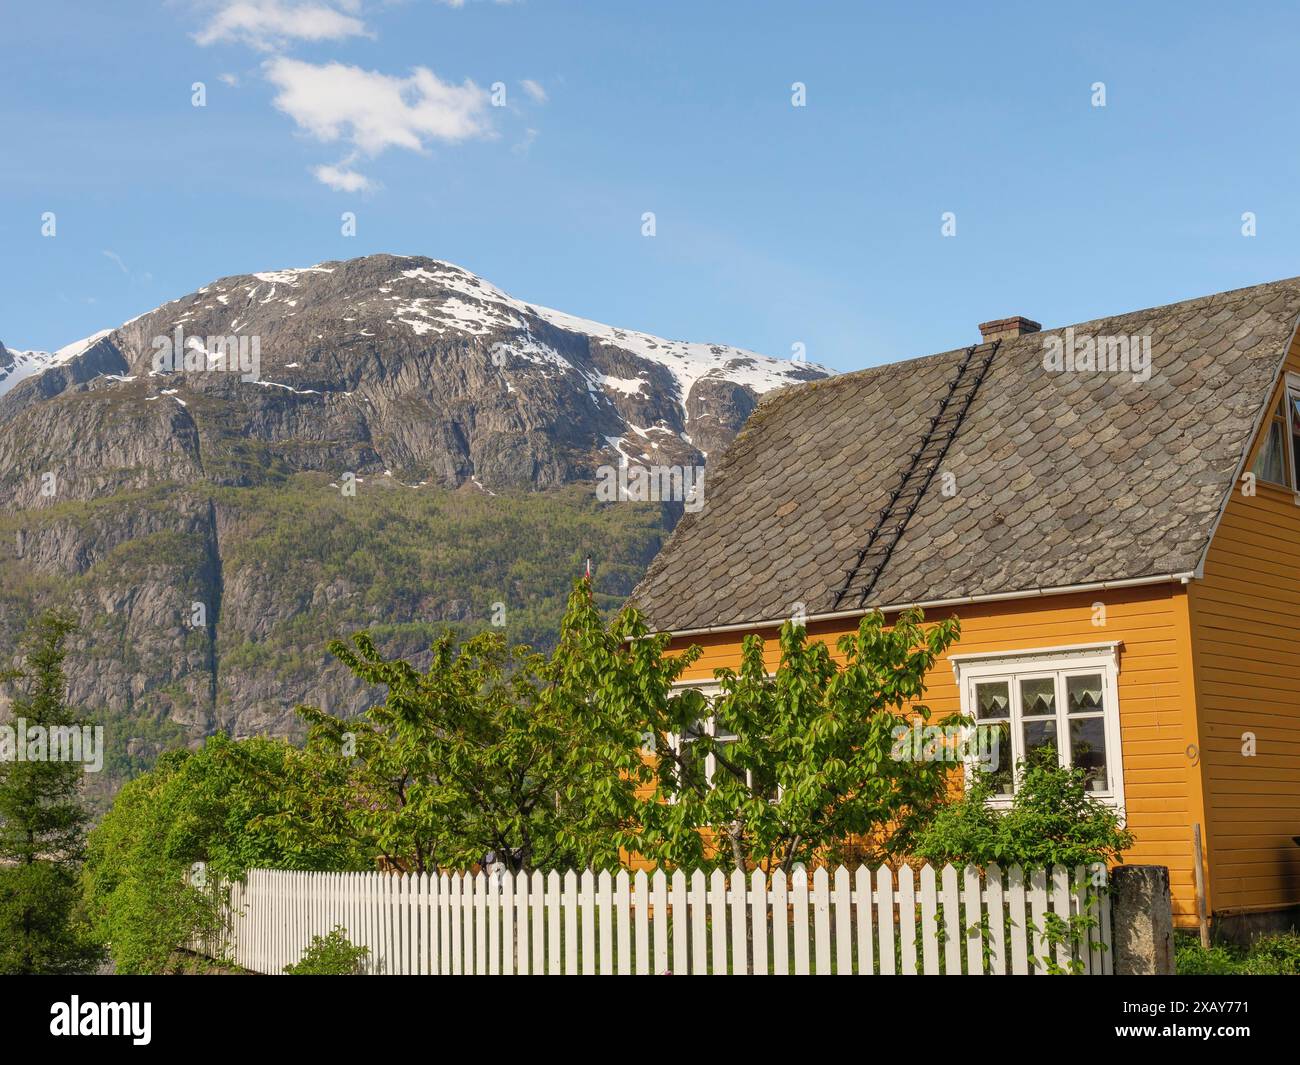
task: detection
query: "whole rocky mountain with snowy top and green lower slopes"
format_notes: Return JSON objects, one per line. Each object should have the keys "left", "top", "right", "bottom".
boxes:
{"left": 0, "top": 255, "right": 826, "bottom": 790}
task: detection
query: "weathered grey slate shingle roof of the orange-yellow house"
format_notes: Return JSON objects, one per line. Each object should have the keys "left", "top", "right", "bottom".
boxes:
{"left": 633, "top": 278, "right": 1300, "bottom": 631}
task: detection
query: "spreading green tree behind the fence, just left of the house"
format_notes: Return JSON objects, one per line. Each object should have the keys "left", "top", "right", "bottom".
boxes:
{"left": 298, "top": 621, "right": 639, "bottom": 873}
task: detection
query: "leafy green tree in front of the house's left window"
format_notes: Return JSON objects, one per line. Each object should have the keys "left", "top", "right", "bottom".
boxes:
{"left": 554, "top": 590, "right": 958, "bottom": 870}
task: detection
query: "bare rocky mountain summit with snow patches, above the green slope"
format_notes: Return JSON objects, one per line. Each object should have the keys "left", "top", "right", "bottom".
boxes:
{"left": 0, "top": 255, "right": 827, "bottom": 489}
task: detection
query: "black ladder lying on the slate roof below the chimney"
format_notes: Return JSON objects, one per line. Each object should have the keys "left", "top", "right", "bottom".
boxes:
{"left": 832, "top": 341, "right": 1001, "bottom": 610}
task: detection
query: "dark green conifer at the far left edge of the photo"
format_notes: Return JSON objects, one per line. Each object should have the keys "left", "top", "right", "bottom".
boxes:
{"left": 0, "top": 611, "right": 101, "bottom": 974}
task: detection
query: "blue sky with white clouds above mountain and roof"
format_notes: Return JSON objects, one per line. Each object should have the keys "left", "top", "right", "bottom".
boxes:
{"left": 0, "top": 0, "right": 1300, "bottom": 369}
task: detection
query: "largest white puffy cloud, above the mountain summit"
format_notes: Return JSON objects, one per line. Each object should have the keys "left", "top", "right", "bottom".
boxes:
{"left": 264, "top": 56, "right": 494, "bottom": 156}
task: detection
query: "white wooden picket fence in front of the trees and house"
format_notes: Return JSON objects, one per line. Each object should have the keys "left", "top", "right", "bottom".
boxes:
{"left": 200, "top": 866, "right": 1110, "bottom": 975}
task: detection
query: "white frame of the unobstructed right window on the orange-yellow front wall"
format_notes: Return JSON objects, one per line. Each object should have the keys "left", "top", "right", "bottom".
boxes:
{"left": 949, "top": 640, "right": 1125, "bottom": 810}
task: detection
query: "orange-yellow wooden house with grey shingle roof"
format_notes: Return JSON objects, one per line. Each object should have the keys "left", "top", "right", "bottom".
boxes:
{"left": 634, "top": 278, "right": 1300, "bottom": 932}
